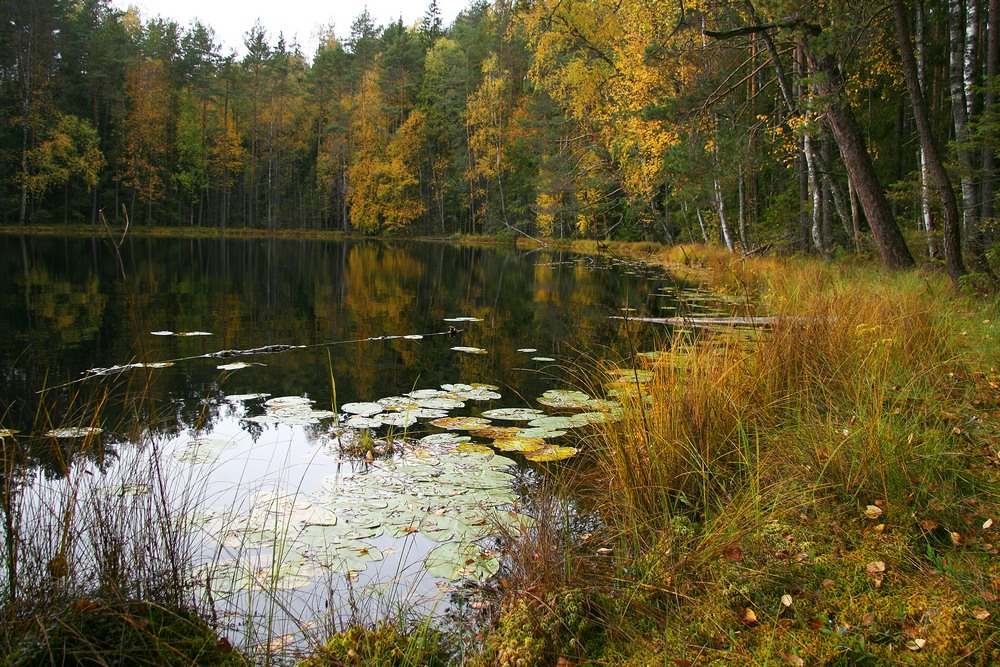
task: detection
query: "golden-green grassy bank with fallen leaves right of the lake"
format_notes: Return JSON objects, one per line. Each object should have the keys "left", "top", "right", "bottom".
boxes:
{"left": 481, "top": 253, "right": 1000, "bottom": 666}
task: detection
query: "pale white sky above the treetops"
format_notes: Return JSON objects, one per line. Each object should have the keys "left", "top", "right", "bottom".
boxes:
{"left": 112, "top": 0, "right": 470, "bottom": 59}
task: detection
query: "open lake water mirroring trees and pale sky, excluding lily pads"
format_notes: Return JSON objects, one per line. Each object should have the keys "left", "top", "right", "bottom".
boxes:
{"left": 0, "top": 237, "right": 704, "bottom": 656}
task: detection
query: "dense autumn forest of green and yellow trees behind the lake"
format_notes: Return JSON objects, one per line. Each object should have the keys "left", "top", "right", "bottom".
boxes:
{"left": 0, "top": 0, "right": 1000, "bottom": 280}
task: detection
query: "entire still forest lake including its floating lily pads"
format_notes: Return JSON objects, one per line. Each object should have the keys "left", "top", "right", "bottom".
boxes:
{"left": 0, "top": 236, "right": 711, "bottom": 656}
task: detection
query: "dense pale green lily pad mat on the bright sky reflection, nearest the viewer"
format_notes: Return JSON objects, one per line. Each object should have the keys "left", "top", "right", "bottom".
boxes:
{"left": 195, "top": 434, "right": 532, "bottom": 594}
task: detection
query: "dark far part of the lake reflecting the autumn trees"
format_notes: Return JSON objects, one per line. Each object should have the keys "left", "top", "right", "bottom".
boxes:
{"left": 0, "top": 236, "right": 688, "bottom": 428}
